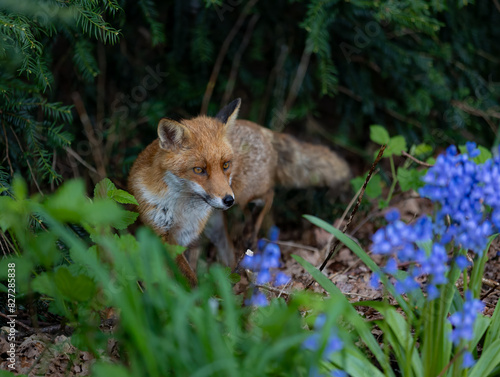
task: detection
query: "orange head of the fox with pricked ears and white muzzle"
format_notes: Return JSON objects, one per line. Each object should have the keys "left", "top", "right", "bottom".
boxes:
{"left": 158, "top": 98, "right": 241, "bottom": 210}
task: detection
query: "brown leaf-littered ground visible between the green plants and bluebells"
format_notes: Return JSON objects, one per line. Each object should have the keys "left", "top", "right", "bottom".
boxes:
{"left": 0, "top": 191, "right": 500, "bottom": 377}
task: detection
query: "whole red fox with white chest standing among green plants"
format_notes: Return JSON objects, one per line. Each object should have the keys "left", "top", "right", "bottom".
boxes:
{"left": 129, "top": 99, "right": 350, "bottom": 284}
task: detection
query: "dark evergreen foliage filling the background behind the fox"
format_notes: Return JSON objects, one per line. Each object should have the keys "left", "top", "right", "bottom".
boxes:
{"left": 0, "top": 0, "right": 500, "bottom": 191}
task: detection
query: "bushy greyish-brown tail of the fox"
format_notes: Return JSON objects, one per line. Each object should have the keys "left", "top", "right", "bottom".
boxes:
{"left": 273, "top": 133, "right": 351, "bottom": 188}
